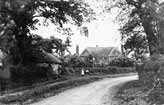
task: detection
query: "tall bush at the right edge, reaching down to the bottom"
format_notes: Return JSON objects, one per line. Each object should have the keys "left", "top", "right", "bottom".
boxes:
{"left": 137, "top": 55, "right": 164, "bottom": 105}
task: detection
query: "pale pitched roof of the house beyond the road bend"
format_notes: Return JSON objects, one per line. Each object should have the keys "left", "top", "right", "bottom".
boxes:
{"left": 80, "top": 47, "right": 121, "bottom": 57}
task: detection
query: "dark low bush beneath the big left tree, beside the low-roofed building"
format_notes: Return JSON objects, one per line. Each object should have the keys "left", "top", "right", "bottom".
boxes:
{"left": 11, "top": 65, "right": 52, "bottom": 86}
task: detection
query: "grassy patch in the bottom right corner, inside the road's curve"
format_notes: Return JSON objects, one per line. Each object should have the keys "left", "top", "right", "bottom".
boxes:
{"left": 112, "top": 77, "right": 164, "bottom": 105}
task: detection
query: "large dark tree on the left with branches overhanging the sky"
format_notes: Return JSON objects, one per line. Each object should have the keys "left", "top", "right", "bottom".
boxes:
{"left": 0, "top": 0, "right": 91, "bottom": 79}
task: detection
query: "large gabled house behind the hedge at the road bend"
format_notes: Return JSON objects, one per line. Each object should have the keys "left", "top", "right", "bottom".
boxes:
{"left": 80, "top": 47, "right": 122, "bottom": 64}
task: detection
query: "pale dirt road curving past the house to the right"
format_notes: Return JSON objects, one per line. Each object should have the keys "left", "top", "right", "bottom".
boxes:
{"left": 32, "top": 76, "right": 137, "bottom": 105}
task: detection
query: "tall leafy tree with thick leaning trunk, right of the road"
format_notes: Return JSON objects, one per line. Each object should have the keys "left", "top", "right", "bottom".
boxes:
{"left": 109, "top": 0, "right": 161, "bottom": 58}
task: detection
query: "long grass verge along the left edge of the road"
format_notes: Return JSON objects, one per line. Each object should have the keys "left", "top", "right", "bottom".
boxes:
{"left": 0, "top": 73, "right": 134, "bottom": 105}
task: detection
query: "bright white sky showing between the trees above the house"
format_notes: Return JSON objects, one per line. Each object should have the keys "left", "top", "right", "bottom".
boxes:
{"left": 30, "top": 0, "right": 121, "bottom": 54}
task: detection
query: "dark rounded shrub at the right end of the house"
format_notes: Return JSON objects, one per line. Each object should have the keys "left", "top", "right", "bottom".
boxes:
{"left": 109, "top": 57, "right": 134, "bottom": 67}
